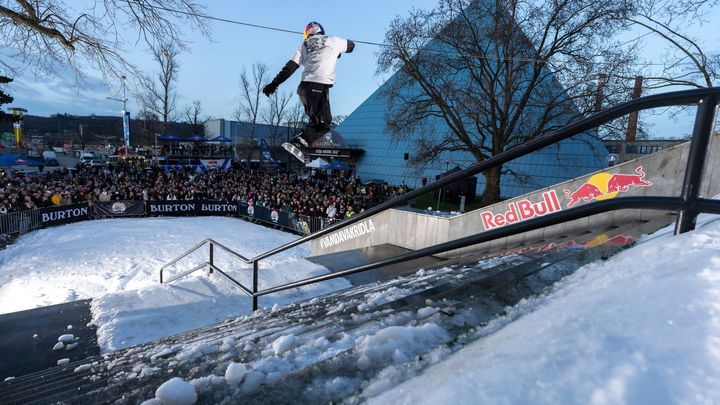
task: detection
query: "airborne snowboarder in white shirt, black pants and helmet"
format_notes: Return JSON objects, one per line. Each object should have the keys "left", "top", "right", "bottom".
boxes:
{"left": 262, "top": 21, "right": 355, "bottom": 161}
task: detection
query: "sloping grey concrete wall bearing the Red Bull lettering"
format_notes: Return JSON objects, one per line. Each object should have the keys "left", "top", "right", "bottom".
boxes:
{"left": 312, "top": 137, "right": 720, "bottom": 256}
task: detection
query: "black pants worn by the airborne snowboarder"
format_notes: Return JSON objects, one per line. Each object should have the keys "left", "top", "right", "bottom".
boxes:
{"left": 298, "top": 82, "right": 332, "bottom": 145}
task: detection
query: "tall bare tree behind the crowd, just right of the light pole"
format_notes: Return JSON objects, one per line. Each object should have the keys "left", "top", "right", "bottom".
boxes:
{"left": 141, "top": 45, "right": 180, "bottom": 134}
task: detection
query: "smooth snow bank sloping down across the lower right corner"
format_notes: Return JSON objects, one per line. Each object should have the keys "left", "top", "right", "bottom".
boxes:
{"left": 366, "top": 217, "right": 720, "bottom": 404}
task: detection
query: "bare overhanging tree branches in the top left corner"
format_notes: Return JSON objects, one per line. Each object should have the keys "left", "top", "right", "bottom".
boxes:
{"left": 0, "top": 0, "right": 209, "bottom": 79}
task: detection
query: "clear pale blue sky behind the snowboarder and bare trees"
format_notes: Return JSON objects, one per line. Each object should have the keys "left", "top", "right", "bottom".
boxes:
{"left": 1, "top": 0, "right": 720, "bottom": 137}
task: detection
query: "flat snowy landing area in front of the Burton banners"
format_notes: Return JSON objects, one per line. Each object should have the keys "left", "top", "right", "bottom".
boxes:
{"left": 0, "top": 217, "right": 350, "bottom": 351}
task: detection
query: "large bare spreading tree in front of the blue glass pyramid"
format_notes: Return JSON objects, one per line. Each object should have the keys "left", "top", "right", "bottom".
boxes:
{"left": 378, "top": 0, "right": 633, "bottom": 204}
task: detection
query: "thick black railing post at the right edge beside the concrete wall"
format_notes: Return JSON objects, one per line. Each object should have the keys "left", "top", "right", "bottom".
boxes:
{"left": 675, "top": 96, "right": 718, "bottom": 235}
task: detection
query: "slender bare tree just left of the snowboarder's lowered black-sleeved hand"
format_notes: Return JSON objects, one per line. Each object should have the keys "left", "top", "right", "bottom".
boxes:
{"left": 235, "top": 63, "right": 268, "bottom": 161}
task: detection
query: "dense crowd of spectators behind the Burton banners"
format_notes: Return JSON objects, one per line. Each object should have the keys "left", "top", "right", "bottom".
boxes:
{"left": 0, "top": 163, "right": 405, "bottom": 219}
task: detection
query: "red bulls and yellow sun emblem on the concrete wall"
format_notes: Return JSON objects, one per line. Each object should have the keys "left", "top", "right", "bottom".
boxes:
{"left": 563, "top": 166, "right": 652, "bottom": 208}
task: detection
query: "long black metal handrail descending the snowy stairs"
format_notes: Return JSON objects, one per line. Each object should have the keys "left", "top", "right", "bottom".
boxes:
{"left": 161, "top": 87, "right": 720, "bottom": 311}
